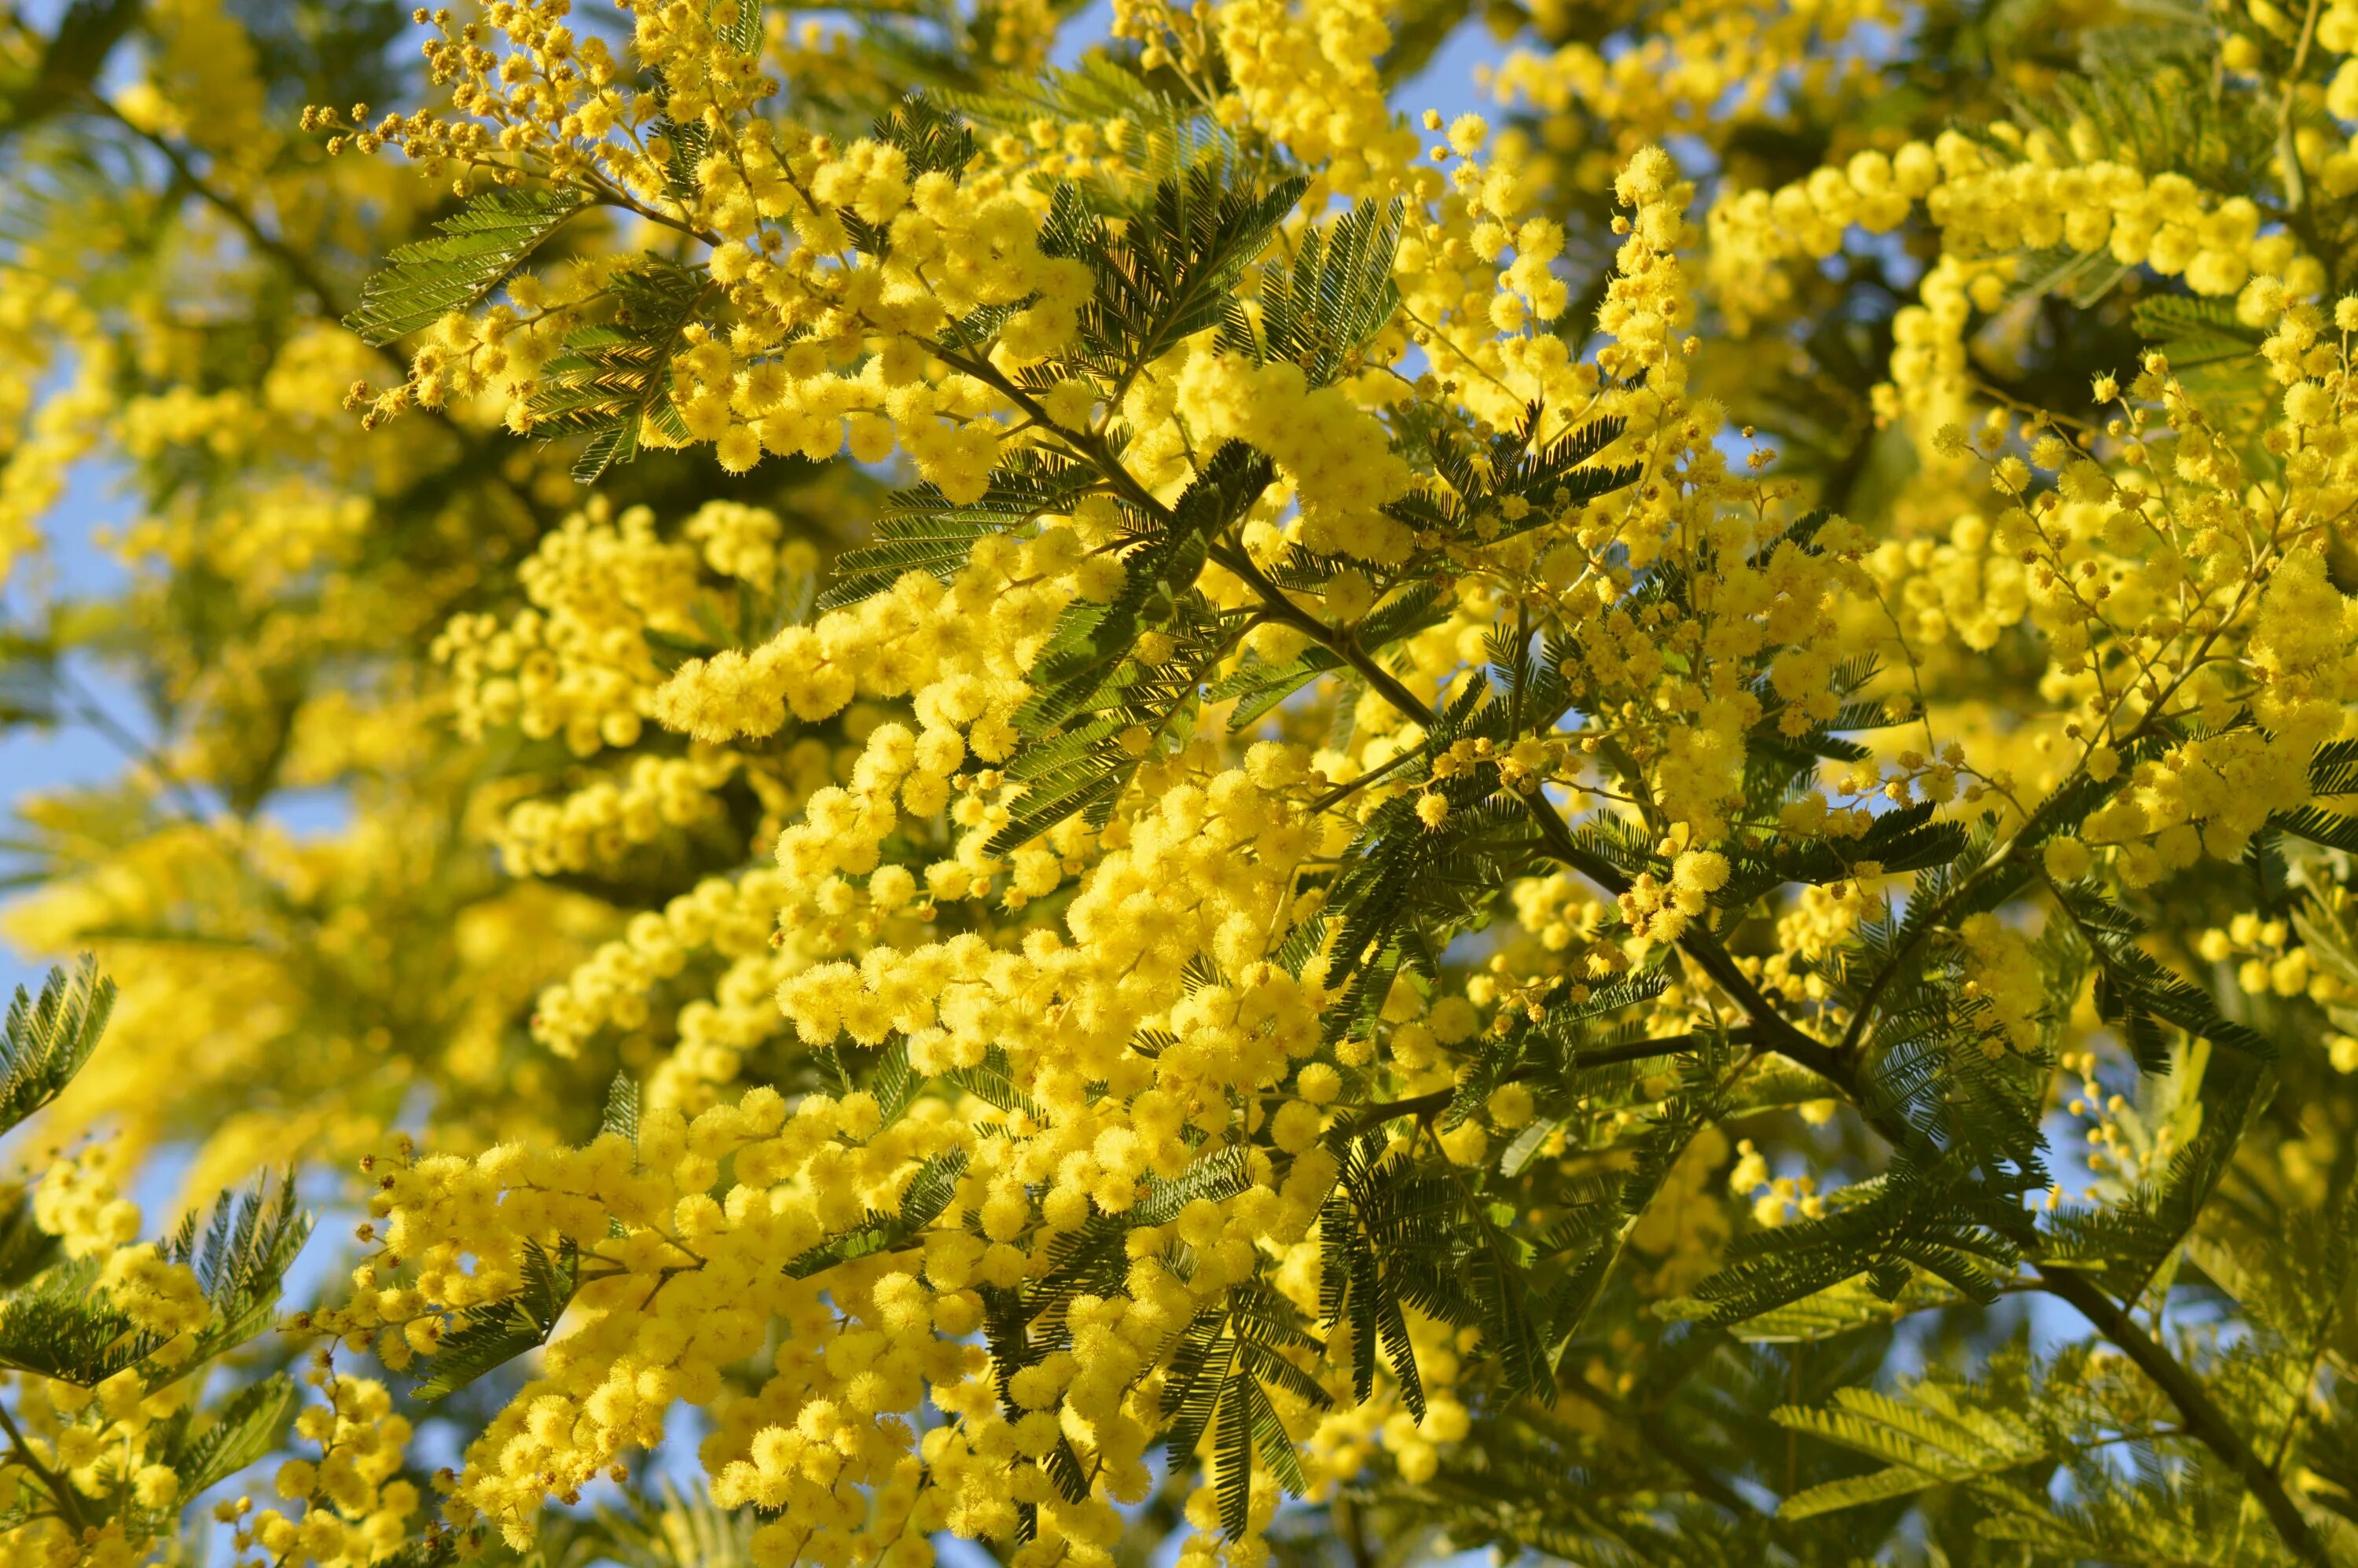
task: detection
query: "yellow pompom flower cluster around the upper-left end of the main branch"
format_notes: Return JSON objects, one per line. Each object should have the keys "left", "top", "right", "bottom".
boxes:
{"left": 325, "top": 5, "right": 1122, "bottom": 500}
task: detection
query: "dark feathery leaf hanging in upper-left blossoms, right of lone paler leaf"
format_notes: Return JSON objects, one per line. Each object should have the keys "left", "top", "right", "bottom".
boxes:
{"left": 526, "top": 257, "right": 707, "bottom": 483}
